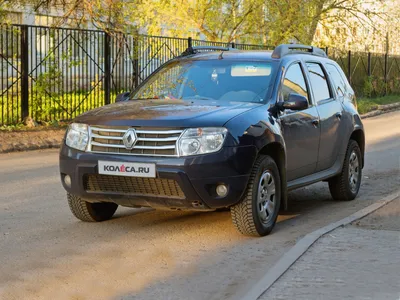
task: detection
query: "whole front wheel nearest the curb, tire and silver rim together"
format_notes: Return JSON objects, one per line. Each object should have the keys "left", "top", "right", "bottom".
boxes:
{"left": 231, "top": 155, "right": 281, "bottom": 236}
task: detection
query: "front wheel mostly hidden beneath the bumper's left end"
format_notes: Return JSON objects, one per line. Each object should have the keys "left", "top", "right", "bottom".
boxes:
{"left": 67, "top": 193, "right": 118, "bottom": 222}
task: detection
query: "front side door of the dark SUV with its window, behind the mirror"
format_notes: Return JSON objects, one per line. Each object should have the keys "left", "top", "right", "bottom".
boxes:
{"left": 280, "top": 62, "right": 320, "bottom": 181}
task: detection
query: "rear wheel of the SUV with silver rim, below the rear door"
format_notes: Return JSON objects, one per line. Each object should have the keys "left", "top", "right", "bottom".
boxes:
{"left": 328, "top": 140, "right": 362, "bottom": 201}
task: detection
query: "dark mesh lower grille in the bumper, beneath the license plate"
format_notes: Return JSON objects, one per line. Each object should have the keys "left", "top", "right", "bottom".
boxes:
{"left": 83, "top": 174, "right": 185, "bottom": 199}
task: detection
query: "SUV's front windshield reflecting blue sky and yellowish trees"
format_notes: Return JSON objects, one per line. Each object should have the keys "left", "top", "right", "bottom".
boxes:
{"left": 131, "top": 60, "right": 275, "bottom": 103}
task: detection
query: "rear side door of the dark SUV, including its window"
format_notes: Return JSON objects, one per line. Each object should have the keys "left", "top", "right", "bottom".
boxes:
{"left": 306, "top": 61, "right": 344, "bottom": 172}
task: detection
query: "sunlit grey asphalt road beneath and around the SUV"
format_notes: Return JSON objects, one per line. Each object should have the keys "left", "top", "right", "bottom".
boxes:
{"left": 0, "top": 112, "right": 400, "bottom": 299}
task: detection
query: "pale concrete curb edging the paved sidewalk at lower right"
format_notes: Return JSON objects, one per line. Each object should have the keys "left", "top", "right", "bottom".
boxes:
{"left": 241, "top": 190, "right": 400, "bottom": 300}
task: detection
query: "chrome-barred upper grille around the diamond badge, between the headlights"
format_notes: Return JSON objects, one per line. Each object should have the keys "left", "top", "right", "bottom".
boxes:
{"left": 88, "top": 126, "right": 183, "bottom": 156}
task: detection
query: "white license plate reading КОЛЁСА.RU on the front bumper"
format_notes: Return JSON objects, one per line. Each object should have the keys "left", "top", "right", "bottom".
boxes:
{"left": 99, "top": 161, "right": 156, "bottom": 178}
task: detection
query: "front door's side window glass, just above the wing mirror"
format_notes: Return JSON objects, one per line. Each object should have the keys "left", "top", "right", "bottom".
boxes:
{"left": 281, "top": 63, "right": 308, "bottom": 101}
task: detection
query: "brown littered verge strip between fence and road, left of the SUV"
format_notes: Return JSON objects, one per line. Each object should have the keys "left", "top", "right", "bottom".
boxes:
{"left": 0, "top": 128, "right": 65, "bottom": 153}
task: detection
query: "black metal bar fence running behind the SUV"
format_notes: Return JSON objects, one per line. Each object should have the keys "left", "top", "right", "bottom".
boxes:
{"left": 0, "top": 24, "right": 400, "bottom": 125}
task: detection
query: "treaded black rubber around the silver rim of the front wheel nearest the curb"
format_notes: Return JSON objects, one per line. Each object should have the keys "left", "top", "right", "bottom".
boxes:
{"left": 231, "top": 155, "right": 281, "bottom": 236}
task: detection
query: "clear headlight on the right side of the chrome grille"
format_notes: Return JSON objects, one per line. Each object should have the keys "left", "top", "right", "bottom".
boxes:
{"left": 178, "top": 127, "right": 228, "bottom": 156}
